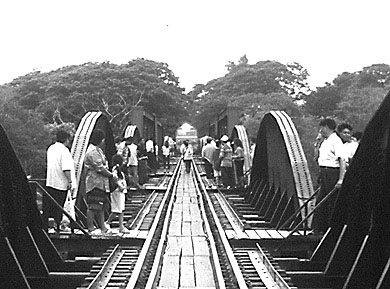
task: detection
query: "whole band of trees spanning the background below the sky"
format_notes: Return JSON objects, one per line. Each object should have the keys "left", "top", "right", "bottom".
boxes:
{"left": 0, "top": 55, "right": 390, "bottom": 177}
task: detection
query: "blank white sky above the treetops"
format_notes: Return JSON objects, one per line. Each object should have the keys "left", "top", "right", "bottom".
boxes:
{"left": 0, "top": 0, "right": 390, "bottom": 92}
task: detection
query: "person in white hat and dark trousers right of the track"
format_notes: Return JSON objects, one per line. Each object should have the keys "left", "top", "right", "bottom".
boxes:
{"left": 219, "top": 135, "right": 234, "bottom": 189}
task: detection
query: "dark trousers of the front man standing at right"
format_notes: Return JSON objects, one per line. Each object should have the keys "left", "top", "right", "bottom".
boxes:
{"left": 312, "top": 167, "right": 340, "bottom": 232}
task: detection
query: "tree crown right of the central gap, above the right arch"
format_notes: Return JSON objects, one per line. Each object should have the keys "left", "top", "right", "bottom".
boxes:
{"left": 188, "top": 56, "right": 308, "bottom": 134}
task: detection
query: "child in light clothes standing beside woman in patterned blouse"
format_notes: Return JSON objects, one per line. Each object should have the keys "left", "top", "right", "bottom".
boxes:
{"left": 106, "top": 154, "right": 130, "bottom": 233}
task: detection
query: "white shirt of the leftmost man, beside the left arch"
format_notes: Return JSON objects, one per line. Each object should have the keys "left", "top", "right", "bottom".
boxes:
{"left": 46, "top": 142, "right": 76, "bottom": 191}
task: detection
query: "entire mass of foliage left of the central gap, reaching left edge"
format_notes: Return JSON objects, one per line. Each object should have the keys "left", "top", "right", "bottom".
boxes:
{"left": 0, "top": 59, "right": 186, "bottom": 177}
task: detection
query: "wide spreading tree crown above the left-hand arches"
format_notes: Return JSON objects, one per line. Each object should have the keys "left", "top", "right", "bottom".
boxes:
{"left": 12, "top": 59, "right": 186, "bottom": 133}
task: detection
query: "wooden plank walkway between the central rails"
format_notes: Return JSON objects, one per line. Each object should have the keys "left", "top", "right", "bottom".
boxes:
{"left": 158, "top": 167, "right": 215, "bottom": 288}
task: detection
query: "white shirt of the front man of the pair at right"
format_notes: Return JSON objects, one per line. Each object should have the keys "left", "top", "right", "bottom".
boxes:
{"left": 318, "top": 132, "right": 345, "bottom": 168}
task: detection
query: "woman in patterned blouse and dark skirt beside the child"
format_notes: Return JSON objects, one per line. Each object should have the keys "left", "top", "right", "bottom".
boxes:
{"left": 84, "top": 129, "right": 117, "bottom": 234}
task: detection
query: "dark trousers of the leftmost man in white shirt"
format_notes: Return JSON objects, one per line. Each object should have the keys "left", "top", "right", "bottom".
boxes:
{"left": 42, "top": 187, "right": 68, "bottom": 231}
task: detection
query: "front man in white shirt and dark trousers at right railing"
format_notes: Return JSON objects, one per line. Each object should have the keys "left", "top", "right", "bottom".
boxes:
{"left": 313, "top": 118, "right": 346, "bottom": 234}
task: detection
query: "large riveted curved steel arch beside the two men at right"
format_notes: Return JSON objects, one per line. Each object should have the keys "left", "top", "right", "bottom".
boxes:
{"left": 251, "top": 111, "right": 314, "bottom": 218}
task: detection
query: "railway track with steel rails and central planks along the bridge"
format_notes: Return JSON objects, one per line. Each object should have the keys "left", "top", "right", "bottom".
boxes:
{"left": 79, "top": 162, "right": 293, "bottom": 289}
